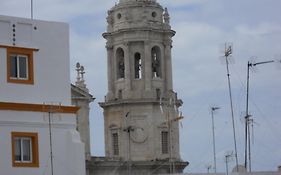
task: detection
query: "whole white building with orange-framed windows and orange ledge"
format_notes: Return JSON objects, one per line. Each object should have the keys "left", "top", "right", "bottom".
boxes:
{"left": 0, "top": 16, "right": 85, "bottom": 175}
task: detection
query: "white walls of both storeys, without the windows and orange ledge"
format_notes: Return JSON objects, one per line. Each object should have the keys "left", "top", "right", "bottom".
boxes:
{"left": 0, "top": 16, "right": 85, "bottom": 175}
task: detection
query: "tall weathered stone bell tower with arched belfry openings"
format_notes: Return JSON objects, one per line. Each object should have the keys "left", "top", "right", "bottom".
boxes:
{"left": 97, "top": 0, "right": 187, "bottom": 174}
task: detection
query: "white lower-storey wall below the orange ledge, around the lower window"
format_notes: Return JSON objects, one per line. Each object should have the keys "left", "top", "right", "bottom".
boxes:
{"left": 0, "top": 111, "right": 85, "bottom": 175}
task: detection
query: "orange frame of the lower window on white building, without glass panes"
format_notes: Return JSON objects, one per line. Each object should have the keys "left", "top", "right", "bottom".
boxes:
{"left": 11, "top": 132, "right": 39, "bottom": 167}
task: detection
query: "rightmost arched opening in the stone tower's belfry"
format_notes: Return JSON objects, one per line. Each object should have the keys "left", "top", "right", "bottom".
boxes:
{"left": 151, "top": 46, "right": 162, "bottom": 78}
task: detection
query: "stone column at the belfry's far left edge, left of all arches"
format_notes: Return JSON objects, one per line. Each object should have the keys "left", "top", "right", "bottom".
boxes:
{"left": 106, "top": 44, "right": 115, "bottom": 100}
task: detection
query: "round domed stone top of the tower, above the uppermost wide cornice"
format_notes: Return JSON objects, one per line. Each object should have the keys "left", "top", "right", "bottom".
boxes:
{"left": 107, "top": 0, "right": 171, "bottom": 32}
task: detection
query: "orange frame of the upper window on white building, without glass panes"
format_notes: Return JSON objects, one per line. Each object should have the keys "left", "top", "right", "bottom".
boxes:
{"left": 7, "top": 47, "right": 34, "bottom": 84}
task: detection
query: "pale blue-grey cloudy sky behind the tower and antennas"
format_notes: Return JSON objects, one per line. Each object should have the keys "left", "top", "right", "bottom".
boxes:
{"left": 0, "top": 0, "right": 281, "bottom": 172}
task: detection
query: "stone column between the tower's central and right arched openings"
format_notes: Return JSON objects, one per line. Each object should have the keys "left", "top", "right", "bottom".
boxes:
{"left": 144, "top": 41, "right": 152, "bottom": 91}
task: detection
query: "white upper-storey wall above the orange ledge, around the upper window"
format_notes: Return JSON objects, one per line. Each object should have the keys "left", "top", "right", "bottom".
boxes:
{"left": 0, "top": 15, "right": 71, "bottom": 105}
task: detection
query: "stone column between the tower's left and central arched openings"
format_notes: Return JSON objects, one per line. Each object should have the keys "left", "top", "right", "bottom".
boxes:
{"left": 124, "top": 42, "right": 131, "bottom": 91}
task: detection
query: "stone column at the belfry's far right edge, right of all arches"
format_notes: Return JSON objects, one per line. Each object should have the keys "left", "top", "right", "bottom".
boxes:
{"left": 164, "top": 41, "right": 173, "bottom": 90}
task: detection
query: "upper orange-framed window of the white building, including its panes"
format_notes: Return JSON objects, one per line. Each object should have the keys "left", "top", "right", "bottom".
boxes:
{"left": 7, "top": 48, "right": 33, "bottom": 84}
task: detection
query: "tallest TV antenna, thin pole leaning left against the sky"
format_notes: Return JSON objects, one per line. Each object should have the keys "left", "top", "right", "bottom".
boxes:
{"left": 220, "top": 43, "right": 238, "bottom": 172}
